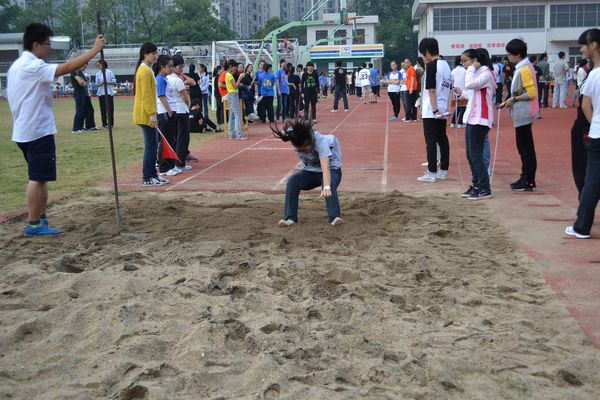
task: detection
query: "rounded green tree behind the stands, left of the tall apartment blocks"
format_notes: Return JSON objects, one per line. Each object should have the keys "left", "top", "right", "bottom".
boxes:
{"left": 165, "top": 0, "right": 236, "bottom": 43}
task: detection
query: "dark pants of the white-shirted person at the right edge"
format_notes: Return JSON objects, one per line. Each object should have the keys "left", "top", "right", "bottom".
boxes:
{"left": 573, "top": 139, "right": 600, "bottom": 235}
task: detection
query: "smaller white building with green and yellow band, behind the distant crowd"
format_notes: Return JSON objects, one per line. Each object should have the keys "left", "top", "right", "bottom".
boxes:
{"left": 301, "top": 13, "right": 384, "bottom": 73}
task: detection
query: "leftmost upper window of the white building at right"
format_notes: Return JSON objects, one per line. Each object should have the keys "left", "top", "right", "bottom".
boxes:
{"left": 433, "top": 7, "right": 486, "bottom": 31}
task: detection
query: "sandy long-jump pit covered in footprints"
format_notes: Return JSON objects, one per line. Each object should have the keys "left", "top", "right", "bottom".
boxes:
{"left": 0, "top": 192, "right": 600, "bottom": 400}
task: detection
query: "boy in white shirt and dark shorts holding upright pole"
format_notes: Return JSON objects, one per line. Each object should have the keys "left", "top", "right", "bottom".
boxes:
{"left": 6, "top": 23, "right": 105, "bottom": 236}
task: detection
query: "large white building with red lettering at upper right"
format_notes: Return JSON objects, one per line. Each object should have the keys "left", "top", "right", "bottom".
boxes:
{"left": 412, "top": 0, "right": 600, "bottom": 65}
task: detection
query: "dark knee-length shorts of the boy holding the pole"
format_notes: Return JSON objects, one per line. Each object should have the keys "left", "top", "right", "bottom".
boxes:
{"left": 17, "top": 135, "right": 56, "bottom": 182}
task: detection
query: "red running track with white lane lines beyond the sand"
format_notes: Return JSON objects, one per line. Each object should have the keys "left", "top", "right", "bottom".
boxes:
{"left": 120, "top": 96, "right": 600, "bottom": 349}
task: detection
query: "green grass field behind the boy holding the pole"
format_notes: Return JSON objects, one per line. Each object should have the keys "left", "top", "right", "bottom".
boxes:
{"left": 0, "top": 97, "right": 212, "bottom": 213}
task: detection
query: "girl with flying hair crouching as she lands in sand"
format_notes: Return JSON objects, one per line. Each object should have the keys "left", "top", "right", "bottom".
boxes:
{"left": 271, "top": 119, "right": 344, "bottom": 228}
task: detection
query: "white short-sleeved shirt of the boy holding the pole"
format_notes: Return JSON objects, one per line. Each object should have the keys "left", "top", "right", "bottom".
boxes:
{"left": 6, "top": 51, "right": 58, "bottom": 143}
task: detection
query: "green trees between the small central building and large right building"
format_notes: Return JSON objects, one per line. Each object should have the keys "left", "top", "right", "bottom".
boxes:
{"left": 348, "top": 0, "right": 417, "bottom": 65}
